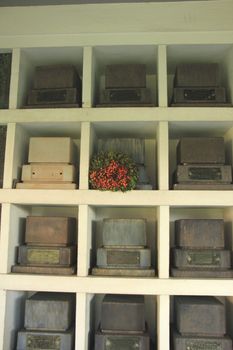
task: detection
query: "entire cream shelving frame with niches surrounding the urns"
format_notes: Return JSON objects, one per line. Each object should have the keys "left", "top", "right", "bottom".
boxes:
{"left": 0, "top": 0, "right": 233, "bottom": 350}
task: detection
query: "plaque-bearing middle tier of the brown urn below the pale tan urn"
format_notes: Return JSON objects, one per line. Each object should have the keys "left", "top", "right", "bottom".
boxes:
{"left": 18, "top": 245, "right": 77, "bottom": 266}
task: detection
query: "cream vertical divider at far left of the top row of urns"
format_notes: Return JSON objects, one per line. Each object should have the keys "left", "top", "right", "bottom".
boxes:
{"left": 9, "top": 48, "right": 21, "bottom": 109}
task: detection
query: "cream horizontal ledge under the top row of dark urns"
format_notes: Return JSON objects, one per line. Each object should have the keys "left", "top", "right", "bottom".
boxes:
{"left": 0, "top": 107, "right": 233, "bottom": 124}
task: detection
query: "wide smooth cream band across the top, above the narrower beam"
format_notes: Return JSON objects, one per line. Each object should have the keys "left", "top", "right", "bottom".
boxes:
{"left": 0, "top": 0, "right": 233, "bottom": 38}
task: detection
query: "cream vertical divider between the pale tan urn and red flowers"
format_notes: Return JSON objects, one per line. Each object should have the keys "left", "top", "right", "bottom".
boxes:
{"left": 79, "top": 122, "right": 94, "bottom": 190}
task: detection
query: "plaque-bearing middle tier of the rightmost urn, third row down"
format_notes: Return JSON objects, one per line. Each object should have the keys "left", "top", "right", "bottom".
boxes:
{"left": 172, "top": 248, "right": 231, "bottom": 270}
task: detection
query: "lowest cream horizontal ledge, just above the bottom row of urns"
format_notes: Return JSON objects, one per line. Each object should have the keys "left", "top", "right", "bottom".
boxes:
{"left": 0, "top": 274, "right": 233, "bottom": 296}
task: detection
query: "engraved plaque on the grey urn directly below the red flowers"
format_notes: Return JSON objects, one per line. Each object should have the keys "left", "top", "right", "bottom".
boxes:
{"left": 107, "top": 250, "right": 140, "bottom": 265}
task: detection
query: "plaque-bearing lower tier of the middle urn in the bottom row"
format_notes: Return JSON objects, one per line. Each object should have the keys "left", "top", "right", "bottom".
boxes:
{"left": 95, "top": 331, "right": 149, "bottom": 350}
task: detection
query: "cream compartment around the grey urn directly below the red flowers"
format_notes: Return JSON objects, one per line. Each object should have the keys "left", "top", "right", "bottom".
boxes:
{"left": 78, "top": 205, "right": 158, "bottom": 279}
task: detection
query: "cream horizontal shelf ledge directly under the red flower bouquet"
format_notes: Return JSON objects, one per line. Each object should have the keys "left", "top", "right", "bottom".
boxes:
{"left": 0, "top": 189, "right": 233, "bottom": 207}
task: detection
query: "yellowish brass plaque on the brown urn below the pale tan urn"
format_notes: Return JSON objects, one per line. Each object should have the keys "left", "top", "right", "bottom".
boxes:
{"left": 27, "top": 248, "right": 60, "bottom": 264}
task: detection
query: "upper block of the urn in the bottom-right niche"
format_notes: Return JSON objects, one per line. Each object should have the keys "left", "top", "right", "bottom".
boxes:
{"left": 174, "top": 296, "right": 226, "bottom": 336}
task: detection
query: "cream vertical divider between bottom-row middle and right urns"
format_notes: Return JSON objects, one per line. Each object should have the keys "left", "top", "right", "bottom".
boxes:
{"left": 157, "top": 295, "right": 170, "bottom": 350}
